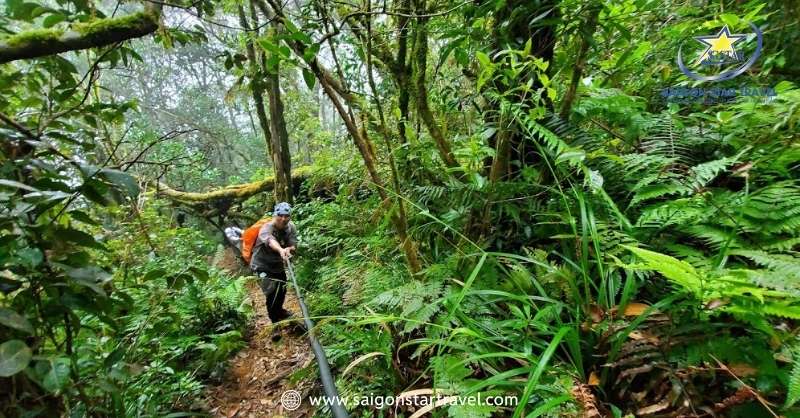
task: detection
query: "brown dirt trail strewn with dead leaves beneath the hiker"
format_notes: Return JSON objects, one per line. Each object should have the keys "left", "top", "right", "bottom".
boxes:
{"left": 206, "top": 248, "right": 316, "bottom": 418}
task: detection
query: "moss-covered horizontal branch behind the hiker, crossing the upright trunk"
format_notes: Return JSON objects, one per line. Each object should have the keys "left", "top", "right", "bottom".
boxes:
{"left": 148, "top": 167, "right": 313, "bottom": 205}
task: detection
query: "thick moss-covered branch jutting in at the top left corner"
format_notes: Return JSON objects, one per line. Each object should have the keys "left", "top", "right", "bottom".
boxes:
{"left": 0, "top": 3, "right": 161, "bottom": 64}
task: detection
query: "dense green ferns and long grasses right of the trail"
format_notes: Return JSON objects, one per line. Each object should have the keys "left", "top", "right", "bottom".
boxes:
{"left": 296, "top": 79, "right": 800, "bottom": 417}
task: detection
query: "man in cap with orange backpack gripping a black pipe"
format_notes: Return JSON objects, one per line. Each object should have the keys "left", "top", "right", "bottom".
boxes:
{"left": 250, "top": 202, "right": 297, "bottom": 324}
